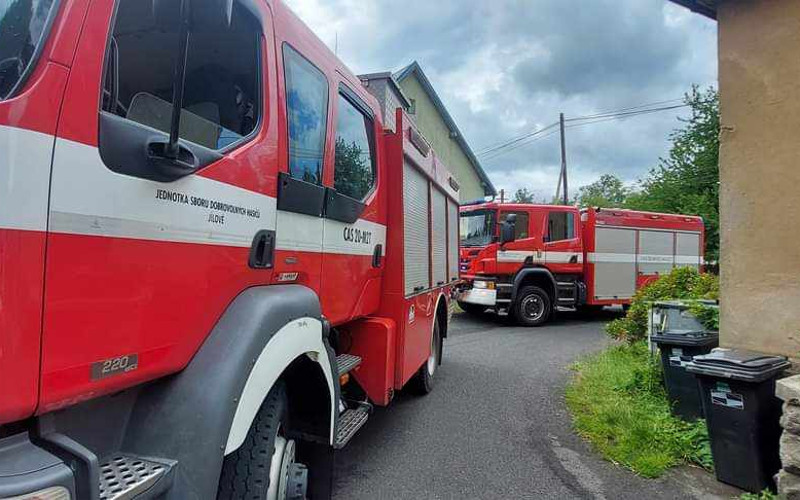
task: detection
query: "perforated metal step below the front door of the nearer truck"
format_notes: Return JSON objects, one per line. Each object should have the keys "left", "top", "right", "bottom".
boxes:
{"left": 100, "top": 454, "right": 172, "bottom": 500}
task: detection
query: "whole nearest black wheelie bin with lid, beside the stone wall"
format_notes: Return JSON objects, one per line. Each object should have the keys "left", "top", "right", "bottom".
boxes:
{"left": 687, "top": 348, "right": 791, "bottom": 493}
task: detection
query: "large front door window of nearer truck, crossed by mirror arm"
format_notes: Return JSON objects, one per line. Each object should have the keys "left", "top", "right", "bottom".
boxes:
{"left": 103, "top": 0, "right": 261, "bottom": 150}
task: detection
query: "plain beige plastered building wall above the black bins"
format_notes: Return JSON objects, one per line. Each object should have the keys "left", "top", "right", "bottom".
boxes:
{"left": 718, "top": 0, "right": 800, "bottom": 358}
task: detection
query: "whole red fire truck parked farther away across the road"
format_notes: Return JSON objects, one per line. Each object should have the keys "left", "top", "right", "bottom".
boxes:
{"left": 458, "top": 202, "right": 704, "bottom": 326}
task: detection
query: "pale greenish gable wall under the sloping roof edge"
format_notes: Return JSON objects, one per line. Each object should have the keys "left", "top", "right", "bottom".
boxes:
{"left": 400, "top": 74, "right": 484, "bottom": 202}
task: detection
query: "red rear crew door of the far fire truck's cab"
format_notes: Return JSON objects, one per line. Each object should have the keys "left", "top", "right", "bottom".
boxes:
{"left": 544, "top": 209, "right": 583, "bottom": 274}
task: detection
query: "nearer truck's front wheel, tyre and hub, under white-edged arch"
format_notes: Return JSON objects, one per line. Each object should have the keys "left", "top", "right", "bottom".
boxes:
{"left": 217, "top": 383, "right": 308, "bottom": 500}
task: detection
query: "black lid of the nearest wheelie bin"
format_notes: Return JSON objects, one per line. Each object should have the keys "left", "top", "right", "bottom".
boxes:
{"left": 686, "top": 347, "right": 791, "bottom": 382}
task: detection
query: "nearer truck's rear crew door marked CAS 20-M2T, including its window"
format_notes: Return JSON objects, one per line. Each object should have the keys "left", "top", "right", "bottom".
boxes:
{"left": 320, "top": 82, "right": 386, "bottom": 324}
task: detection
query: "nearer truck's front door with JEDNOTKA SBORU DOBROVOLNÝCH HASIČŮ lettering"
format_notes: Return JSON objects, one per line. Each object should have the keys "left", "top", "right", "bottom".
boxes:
{"left": 40, "top": 0, "right": 278, "bottom": 411}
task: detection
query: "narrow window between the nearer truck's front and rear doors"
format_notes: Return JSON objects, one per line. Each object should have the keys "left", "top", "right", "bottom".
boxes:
{"left": 283, "top": 44, "right": 328, "bottom": 184}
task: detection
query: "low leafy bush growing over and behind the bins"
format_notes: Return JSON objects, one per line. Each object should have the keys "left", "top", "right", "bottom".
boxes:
{"left": 606, "top": 267, "right": 719, "bottom": 343}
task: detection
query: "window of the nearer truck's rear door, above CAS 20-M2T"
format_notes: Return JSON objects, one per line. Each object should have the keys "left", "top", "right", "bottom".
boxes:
{"left": 333, "top": 94, "right": 375, "bottom": 200}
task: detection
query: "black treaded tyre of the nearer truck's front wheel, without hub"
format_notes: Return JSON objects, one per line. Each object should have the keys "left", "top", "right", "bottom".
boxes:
{"left": 217, "top": 382, "right": 288, "bottom": 500}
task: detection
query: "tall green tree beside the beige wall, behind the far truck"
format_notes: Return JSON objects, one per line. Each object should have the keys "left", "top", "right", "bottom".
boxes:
{"left": 625, "top": 86, "right": 719, "bottom": 260}
